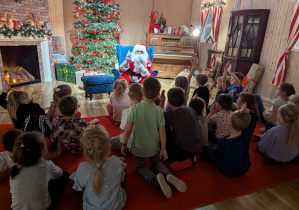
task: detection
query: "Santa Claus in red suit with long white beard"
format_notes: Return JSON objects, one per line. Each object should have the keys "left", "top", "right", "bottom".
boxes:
{"left": 119, "top": 43, "right": 153, "bottom": 86}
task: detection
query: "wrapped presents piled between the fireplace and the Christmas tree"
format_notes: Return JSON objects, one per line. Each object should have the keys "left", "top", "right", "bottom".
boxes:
{"left": 52, "top": 36, "right": 103, "bottom": 88}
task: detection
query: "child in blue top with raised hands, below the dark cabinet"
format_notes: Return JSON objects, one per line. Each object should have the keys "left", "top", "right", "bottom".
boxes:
{"left": 222, "top": 62, "right": 244, "bottom": 103}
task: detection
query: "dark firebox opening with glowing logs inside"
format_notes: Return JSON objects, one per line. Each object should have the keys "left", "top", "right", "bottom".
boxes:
{"left": 0, "top": 45, "right": 41, "bottom": 87}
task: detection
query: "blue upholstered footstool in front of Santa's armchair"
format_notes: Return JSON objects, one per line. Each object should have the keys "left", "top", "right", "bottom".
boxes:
{"left": 81, "top": 69, "right": 120, "bottom": 100}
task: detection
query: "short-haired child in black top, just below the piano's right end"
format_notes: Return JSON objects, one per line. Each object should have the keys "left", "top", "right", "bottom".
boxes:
{"left": 192, "top": 74, "right": 210, "bottom": 106}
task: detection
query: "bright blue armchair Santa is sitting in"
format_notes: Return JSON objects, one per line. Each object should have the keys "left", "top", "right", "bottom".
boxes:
{"left": 116, "top": 45, "right": 158, "bottom": 77}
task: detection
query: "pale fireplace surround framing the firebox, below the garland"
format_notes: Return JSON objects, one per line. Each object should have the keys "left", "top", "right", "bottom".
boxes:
{"left": 0, "top": 36, "right": 55, "bottom": 90}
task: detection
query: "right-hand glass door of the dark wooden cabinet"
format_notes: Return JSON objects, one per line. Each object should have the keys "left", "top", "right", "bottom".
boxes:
{"left": 241, "top": 16, "right": 260, "bottom": 58}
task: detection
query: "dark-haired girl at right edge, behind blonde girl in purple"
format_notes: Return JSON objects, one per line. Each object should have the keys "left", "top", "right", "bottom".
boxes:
{"left": 255, "top": 83, "right": 295, "bottom": 130}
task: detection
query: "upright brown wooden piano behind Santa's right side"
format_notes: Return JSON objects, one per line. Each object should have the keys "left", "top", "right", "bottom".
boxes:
{"left": 146, "top": 33, "right": 198, "bottom": 78}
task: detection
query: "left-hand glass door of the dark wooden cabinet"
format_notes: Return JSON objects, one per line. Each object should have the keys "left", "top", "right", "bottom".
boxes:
{"left": 227, "top": 16, "right": 244, "bottom": 56}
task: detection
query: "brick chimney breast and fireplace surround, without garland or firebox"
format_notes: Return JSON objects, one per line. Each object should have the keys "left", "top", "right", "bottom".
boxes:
{"left": 0, "top": 0, "right": 55, "bottom": 90}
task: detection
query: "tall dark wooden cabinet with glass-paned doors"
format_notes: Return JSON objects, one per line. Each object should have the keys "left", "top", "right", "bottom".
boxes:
{"left": 223, "top": 9, "right": 270, "bottom": 76}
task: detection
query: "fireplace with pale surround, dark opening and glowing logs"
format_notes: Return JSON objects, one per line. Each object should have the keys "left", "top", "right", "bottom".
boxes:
{"left": 0, "top": 36, "right": 55, "bottom": 90}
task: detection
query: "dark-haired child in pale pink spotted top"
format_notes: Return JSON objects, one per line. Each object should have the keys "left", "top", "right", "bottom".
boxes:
{"left": 207, "top": 93, "right": 233, "bottom": 143}
